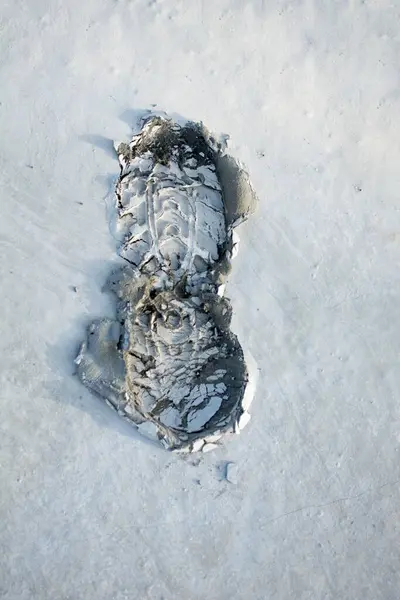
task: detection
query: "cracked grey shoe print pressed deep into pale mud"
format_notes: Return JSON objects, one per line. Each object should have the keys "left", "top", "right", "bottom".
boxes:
{"left": 76, "top": 115, "right": 256, "bottom": 451}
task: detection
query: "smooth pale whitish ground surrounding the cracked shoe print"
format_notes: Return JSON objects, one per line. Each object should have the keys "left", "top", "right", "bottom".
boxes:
{"left": 0, "top": 0, "right": 400, "bottom": 600}
